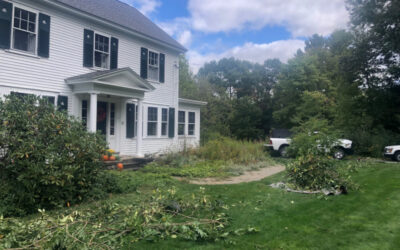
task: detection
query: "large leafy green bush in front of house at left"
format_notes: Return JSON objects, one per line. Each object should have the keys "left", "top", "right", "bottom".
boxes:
{"left": 0, "top": 95, "right": 107, "bottom": 215}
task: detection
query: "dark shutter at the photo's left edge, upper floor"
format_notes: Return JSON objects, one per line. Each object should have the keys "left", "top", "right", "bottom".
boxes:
{"left": 0, "top": 0, "right": 12, "bottom": 49}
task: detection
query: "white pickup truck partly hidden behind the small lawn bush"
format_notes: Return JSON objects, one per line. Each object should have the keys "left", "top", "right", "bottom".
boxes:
{"left": 264, "top": 129, "right": 353, "bottom": 160}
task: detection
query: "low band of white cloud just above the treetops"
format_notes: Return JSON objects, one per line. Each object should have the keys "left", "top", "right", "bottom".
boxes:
{"left": 187, "top": 39, "right": 304, "bottom": 74}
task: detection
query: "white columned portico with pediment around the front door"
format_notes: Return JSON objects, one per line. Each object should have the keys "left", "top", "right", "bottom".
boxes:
{"left": 65, "top": 68, "right": 154, "bottom": 156}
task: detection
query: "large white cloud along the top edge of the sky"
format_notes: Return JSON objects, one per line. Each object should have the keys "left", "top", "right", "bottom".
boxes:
{"left": 188, "top": 0, "right": 349, "bottom": 37}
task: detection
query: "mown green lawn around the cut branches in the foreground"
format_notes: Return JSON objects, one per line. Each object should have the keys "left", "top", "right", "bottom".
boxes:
{"left": 3, "top": 163, "right": 400, "bottom": 249}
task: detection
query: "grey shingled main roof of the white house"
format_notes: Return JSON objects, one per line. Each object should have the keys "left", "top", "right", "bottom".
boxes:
{"left": 55, "top": 0, "right": 186, "bottom": 51}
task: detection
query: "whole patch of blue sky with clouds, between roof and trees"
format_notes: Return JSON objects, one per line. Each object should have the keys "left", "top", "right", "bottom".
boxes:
{"left": 121, "top": 0, "right": 349, "bottom": 73}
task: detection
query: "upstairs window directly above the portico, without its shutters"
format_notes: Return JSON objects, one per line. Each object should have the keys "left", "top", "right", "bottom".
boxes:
{"left": 94, "top": 33, "right": 110, "bottom": 69}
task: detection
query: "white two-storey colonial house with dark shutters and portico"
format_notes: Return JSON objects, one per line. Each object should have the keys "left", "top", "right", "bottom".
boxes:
{"left": 0, "top": 0, "right": 205, "bottom": 156}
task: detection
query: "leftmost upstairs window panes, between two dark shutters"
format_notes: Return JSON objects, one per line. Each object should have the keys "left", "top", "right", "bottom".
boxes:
{"left": 12, "top": 7, "right": 38, "bottom": 54}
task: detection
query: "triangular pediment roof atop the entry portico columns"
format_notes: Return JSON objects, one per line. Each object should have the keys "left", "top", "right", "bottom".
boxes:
{"left": 65, "top": 67, "right": 155, "bottom": 97}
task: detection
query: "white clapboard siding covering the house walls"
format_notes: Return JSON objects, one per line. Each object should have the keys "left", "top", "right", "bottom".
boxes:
{"left": 0, "top": 0, "right": 200, "bottom": 155}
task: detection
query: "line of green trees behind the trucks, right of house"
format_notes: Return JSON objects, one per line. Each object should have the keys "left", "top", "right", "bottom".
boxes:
{"left": 180, "top": 0, "right": 400, "bottom": 156}
